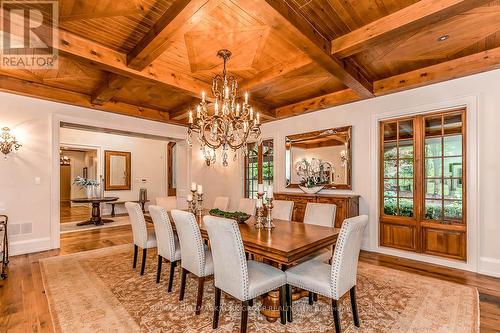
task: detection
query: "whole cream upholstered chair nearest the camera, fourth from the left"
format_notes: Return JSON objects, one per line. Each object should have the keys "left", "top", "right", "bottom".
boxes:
{"left": 204, "top": 215, "right": 286, "bottom": 332}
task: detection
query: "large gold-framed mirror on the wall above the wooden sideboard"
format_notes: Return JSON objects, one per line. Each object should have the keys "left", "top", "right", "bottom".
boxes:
{"left": 285, "top": 126, "right": 352, "bottom": 189}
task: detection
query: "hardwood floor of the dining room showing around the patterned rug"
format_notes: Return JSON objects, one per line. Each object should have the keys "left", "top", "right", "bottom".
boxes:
{"left": 0, "top": 226, "right": 500, "bottom": 333}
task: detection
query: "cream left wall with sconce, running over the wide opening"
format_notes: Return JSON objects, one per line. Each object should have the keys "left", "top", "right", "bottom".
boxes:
{"left": 0, "top": 93, "right": 186, "bottom": 255}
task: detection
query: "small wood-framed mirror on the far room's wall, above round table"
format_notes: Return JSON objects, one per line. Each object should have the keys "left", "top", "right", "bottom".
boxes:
{"left": 104, "top": 150, "right": 131, "bottom": 191}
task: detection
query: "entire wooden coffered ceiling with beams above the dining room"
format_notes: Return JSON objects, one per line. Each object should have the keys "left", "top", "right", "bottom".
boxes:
{"left": 0, "top": 0, "right": 500, "bottom": 124}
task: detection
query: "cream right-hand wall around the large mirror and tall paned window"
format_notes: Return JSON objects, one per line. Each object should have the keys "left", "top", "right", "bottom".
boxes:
{"left": 256, "top": 70, "right": 500, "bottom": 276}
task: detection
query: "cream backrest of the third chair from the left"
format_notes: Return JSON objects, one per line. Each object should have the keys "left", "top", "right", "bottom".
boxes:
{"left": 171, "top": 209, "right": 205, "bottom": 276}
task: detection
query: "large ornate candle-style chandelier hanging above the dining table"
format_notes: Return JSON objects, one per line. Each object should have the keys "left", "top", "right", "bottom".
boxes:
{"left": 187, "top": 50, "right": 260, "bottom": 166}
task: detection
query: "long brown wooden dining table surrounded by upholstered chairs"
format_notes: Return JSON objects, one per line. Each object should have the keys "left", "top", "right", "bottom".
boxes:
{"left": 145, "top": 210, "right": 340, "bottom": 322}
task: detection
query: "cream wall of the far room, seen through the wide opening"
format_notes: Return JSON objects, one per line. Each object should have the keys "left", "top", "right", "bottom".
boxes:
{"left": 59, "top": 128, "right": 168, "bottom": 214}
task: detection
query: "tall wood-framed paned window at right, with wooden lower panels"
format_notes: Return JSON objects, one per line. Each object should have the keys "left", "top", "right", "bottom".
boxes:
{"left": 380, "top": 109, "right": 466, "bottom": 260}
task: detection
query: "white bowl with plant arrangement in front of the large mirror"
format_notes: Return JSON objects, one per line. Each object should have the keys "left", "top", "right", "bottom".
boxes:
{"left": 295, "top": 158, "right": 333, "bottom": 194}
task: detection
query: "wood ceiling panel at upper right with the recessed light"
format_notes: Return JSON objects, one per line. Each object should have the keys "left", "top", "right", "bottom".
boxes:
{"left": 354, "top": 1, "right": 500, "bottom": 80}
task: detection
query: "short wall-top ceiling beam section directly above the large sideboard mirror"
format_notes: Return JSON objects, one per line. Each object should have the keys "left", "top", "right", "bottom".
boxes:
{"left": 275, "top": 89, "right": 362, "bottom": 119}
